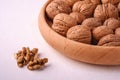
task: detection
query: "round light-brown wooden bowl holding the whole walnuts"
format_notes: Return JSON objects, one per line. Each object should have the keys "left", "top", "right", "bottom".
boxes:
{"left": 38, "top": 0, "right": 120, "bottom": 65}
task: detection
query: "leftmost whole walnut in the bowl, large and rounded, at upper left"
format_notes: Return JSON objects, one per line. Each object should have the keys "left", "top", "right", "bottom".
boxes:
{"left": 46, "top": 1, "right": 71, "bottom": 19}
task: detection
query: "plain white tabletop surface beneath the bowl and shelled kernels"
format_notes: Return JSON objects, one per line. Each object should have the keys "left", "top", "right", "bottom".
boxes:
{"left": 0, "top": 0, "right": 120, "bottom": 80}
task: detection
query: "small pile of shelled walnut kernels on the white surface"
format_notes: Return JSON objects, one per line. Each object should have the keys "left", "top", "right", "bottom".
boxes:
{"left": 15, "top": 47, "right": 48, "bottom": 70}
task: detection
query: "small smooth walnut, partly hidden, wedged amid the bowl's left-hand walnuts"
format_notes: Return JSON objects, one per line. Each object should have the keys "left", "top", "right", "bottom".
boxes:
{"left": 70, "top": 12, "right": 86, "bottom": 24}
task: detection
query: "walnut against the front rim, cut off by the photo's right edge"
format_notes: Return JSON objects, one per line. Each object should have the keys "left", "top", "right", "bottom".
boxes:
{"left": 97, "top": 34, "right": 120, "bottom": 46}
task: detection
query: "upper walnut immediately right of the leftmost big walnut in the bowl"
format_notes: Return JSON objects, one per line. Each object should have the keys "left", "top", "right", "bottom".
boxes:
{"left": 72, "top": 1, "right": 95, "bottom": 17}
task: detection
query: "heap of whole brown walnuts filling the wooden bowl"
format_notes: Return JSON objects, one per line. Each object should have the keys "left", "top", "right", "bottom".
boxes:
{"left": 46, "top": 0, "right": 120, "bottom": 46}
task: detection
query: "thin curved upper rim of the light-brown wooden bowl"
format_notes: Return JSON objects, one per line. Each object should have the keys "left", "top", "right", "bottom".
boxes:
{"left": 38, "top": 0, "right": 120, "bottom": 49}
